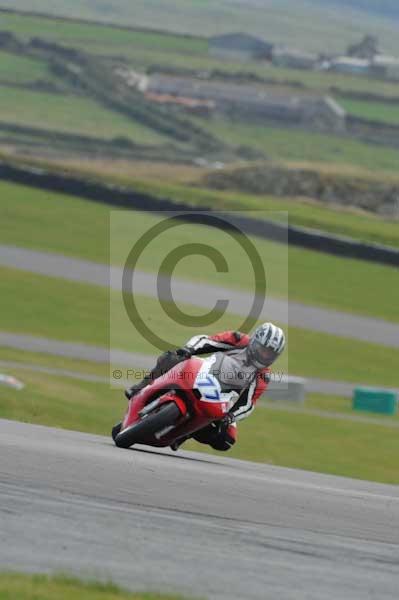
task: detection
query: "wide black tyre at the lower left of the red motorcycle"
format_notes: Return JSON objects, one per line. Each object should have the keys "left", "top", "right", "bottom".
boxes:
{"left": 114, "top": 402, "right": 181, "bottom": 448}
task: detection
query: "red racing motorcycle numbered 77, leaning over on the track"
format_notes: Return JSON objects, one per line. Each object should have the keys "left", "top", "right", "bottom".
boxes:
{"left": 112, "top": 356, "right": 234, "bottom": 448}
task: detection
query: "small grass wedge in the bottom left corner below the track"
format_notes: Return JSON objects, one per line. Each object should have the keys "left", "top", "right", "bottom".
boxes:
{"left": 0, "top": 572, "right": 191, "bottom": 600}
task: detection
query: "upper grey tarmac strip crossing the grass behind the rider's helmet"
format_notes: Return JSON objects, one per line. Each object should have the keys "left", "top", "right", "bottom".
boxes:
{"left": 0, "top": 245, "right": 399, "bottom": 348}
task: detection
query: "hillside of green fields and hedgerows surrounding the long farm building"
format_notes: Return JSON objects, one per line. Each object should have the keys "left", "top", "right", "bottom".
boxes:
{"left": 0, "top": 12, "right": 399, "bottom": 173}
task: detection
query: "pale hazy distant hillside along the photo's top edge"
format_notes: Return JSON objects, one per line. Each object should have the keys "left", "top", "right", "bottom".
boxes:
{"left": 0, "top": 0, "right": 399, "bottom": 54}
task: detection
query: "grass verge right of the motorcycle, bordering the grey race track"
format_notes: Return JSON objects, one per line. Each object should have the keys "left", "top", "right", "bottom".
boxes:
{"left": 184, "top": 400, "right": 399, "bottom": 484}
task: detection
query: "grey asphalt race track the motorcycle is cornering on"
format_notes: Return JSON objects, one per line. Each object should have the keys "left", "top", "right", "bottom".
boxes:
{"left": 0, "top": 420, "right": 399, "bottom": 600}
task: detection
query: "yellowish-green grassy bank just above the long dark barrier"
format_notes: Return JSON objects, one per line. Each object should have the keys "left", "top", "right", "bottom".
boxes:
{"left": 18, "top": 159, "right": 399, "bottom": 247}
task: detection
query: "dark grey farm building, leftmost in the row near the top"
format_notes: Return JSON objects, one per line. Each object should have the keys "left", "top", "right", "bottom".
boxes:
{"left": 208, "top": 33, "right": 273, "bottom": 61}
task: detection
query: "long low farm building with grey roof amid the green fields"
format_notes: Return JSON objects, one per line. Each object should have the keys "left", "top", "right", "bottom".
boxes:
{"left": 146, "top": 75, "right": 346, "bottom": 131}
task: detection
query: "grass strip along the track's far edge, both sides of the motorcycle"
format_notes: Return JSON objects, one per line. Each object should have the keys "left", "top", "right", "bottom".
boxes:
{"left": 0, "top": 354, "right": 399, "bottom": 486}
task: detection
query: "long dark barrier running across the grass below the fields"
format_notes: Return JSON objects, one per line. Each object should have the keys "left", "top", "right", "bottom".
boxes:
{"left": 0, "top": 161, "right": 399, "bottom": 266}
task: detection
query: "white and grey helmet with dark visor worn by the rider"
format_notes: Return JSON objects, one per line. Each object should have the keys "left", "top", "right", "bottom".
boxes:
{"left": 247, "top": 323, "right": 285, "bottom": 369}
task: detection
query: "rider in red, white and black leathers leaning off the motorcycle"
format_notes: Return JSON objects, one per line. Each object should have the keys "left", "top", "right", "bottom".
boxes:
{"left": 125, "top": 323, "right": 285, "bottom": 450}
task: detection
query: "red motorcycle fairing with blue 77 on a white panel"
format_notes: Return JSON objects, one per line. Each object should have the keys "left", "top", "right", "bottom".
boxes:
{"left": 121, "top": 357, "right": 229, "bottom": 446}
